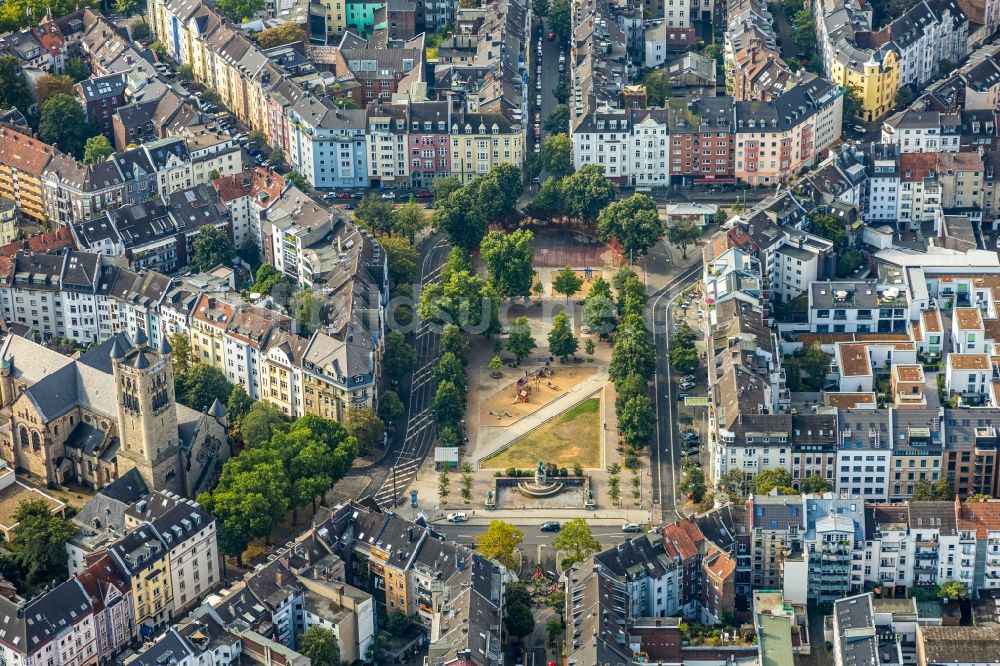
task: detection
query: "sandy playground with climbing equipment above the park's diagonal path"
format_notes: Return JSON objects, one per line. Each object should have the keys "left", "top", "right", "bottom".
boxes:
{"left": 479, "top": 361, "right": 597, "bottom": 426}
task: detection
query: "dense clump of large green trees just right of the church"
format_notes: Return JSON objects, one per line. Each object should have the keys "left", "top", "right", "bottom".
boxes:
{"left": 198, "top": 402, "right": 358, "bottom": 563}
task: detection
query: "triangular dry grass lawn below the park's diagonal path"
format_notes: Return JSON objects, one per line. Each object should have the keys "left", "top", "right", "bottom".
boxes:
{"left": 483, "top": 397, "right": 601, "bottom": 469}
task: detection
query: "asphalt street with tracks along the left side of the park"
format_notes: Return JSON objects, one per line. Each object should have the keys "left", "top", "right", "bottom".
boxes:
{"left": 367, "top": 236, "right": 449, "bottom": 507}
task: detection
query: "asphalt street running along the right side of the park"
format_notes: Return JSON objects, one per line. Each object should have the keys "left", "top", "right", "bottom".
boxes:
{"left": 650, "top": 260, "right": 701, "bottom": 522}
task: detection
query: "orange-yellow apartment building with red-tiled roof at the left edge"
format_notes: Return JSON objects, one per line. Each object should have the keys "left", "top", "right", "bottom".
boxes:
{"left": 0, "top": 127, "right": 55, "bottom": 222}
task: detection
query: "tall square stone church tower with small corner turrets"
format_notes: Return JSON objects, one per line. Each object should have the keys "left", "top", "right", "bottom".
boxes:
{"left": 111, "top": 330, "right": 183, "bottom": 493}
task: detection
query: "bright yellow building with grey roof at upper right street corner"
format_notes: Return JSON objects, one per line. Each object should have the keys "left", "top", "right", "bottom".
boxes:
{"left": 830, "top": 41, "right": 902, "bottom": 122}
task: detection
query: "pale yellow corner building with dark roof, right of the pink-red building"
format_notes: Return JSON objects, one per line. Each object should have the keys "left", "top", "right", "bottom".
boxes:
{"left": 451, "top": 113, "right": 524, "bottom": 183}
